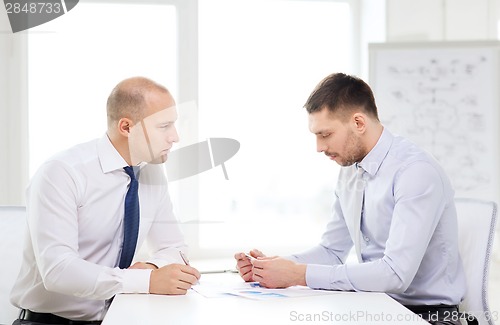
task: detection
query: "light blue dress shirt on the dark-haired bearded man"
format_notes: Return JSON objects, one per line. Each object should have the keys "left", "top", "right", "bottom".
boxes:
{"left": 291, "top": 129, "right": 465, "bottom": 305}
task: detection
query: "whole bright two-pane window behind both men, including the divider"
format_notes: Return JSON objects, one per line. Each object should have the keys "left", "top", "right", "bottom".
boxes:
{"left": 28, "top": 0, "right": 359, "bottom": 258}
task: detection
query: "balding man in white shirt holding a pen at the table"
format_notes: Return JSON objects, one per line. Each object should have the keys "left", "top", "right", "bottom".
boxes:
{"left": 11, "top": 77, "right": 200, "bottom": 325}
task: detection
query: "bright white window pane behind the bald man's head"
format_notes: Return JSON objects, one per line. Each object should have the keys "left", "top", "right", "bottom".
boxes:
{"left": 28, "top": 2, "right": 177, "bottom": 176}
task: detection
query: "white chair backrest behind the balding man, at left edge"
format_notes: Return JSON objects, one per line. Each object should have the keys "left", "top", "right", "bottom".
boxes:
{"left": 0, "top": 206, "right": 26, "bottom": 324}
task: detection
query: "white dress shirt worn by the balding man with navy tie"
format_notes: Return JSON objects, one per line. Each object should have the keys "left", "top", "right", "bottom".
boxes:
{"left": 11, "top": 135, "right": 186, "bottom": 320}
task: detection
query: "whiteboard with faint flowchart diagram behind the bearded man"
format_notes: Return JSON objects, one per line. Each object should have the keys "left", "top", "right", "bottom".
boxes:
{"left": 372, "top": 44, "right": 498, "bottom": 196}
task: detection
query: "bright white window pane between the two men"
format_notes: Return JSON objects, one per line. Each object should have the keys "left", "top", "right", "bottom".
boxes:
{"left": 195, "top": 0, "right": 353, "bottom": 253}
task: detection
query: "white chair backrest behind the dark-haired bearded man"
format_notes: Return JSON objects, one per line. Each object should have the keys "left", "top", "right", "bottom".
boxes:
{"left": 455, "top": 198, "right": 497, "bottom": 325}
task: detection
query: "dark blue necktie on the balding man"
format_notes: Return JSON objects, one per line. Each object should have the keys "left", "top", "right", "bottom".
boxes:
{"left": 119, "top": 166, "right": 139, "bottom": 269}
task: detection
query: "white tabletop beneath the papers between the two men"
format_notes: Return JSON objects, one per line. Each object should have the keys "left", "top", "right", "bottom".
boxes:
{"left": 102, "top": 274, "right": 426, "bottom": 325}
